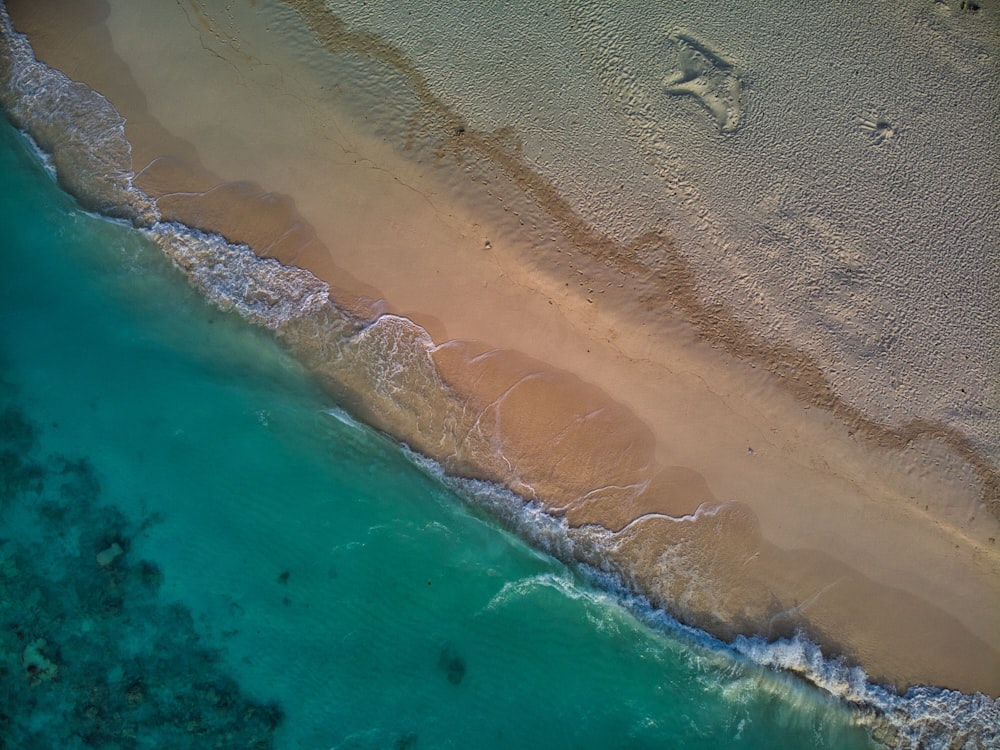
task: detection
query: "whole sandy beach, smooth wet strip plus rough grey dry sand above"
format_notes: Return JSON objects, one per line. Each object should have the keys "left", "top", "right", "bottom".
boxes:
{"left": 7, "top": 0, "right": 1000, "bottom": 696}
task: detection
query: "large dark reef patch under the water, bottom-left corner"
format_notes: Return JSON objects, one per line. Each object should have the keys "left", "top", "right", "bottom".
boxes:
{"left": 0, "top": 404, "right": 283, "bottom": 750}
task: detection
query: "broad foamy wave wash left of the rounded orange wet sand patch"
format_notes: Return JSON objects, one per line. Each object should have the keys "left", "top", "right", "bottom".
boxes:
{"left": 147, "top": 222, "right": 476, "bottom": 472}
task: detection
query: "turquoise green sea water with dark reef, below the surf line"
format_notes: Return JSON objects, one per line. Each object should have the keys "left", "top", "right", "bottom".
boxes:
{"left": 0, "top": 117, "right": 868, "bottom": 748}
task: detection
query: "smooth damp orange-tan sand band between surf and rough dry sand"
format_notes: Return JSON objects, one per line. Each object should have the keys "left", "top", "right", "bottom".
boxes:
{"left": 7, "top": 0, "right": 1000, "bottom": 696}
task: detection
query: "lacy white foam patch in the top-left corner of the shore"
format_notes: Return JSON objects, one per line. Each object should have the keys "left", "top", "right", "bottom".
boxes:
{"left": 0, "top": 2, "right": 159, "bottom": 226}
